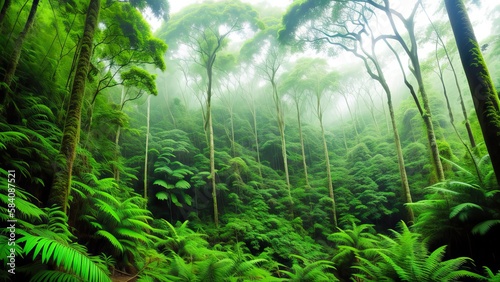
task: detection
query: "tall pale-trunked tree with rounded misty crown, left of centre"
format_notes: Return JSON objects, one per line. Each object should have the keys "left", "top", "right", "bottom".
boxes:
{"left": 159, "top": 1, "right": 259, "bottom": 227}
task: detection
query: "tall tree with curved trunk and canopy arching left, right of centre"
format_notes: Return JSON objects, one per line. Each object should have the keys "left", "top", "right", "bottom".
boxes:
{"left": 279, "top": 0, "right": 414, "bottom": 225}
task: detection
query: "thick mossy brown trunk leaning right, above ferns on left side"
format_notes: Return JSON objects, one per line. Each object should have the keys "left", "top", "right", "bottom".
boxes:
{"left": 49, "top": 0, "right": 101, "bottom": 213}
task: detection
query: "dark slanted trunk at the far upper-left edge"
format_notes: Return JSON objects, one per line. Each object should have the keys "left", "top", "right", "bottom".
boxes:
{"left": 0, "top": 0, "right": 40, "bottom": 103}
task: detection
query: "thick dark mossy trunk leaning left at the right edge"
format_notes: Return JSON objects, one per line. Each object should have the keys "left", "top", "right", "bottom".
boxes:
{"left": 444, "top": 0, "right": 500, "bottom": 183}
